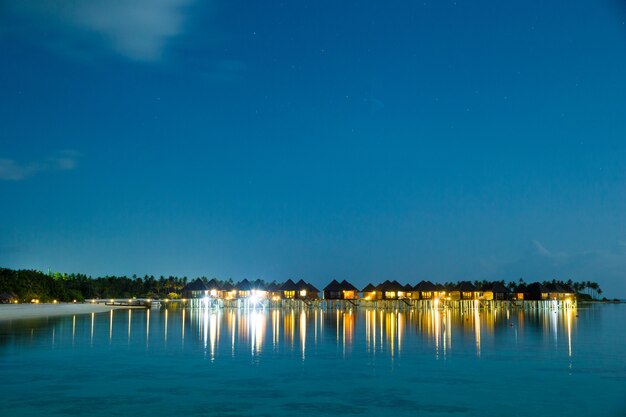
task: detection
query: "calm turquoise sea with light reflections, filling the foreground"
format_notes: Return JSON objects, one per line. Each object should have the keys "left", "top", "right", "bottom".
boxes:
{"left": 0, "top": 305, "right": 626, "bottom": 416}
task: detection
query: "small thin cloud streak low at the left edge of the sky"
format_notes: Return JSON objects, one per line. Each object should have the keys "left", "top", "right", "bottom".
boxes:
{"left": 0, "top": 150, "right": 81, "bottom": 181}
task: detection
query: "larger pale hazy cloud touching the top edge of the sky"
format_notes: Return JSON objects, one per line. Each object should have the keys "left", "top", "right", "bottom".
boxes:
{"left": 0, "top": 0, "right": 193, "bottom": 62}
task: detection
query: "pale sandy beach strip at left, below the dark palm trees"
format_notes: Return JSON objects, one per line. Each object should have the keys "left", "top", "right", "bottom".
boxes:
{"left": 0, "top": 303, "right": 136, "bottom": 322}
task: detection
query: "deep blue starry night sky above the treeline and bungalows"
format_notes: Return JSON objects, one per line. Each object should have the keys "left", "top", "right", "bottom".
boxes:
{"left": 0, "top": 0, "right": 626, "bottom": 297}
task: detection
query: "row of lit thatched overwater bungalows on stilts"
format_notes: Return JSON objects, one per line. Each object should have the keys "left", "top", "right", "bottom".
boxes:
{"left": 177, "top": 278, "right": 576, "bottom": 308}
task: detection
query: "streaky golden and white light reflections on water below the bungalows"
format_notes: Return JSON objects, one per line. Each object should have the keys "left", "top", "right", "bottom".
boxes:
{"left": 0, "top": 308, "right": 577, "bottom": 360}
